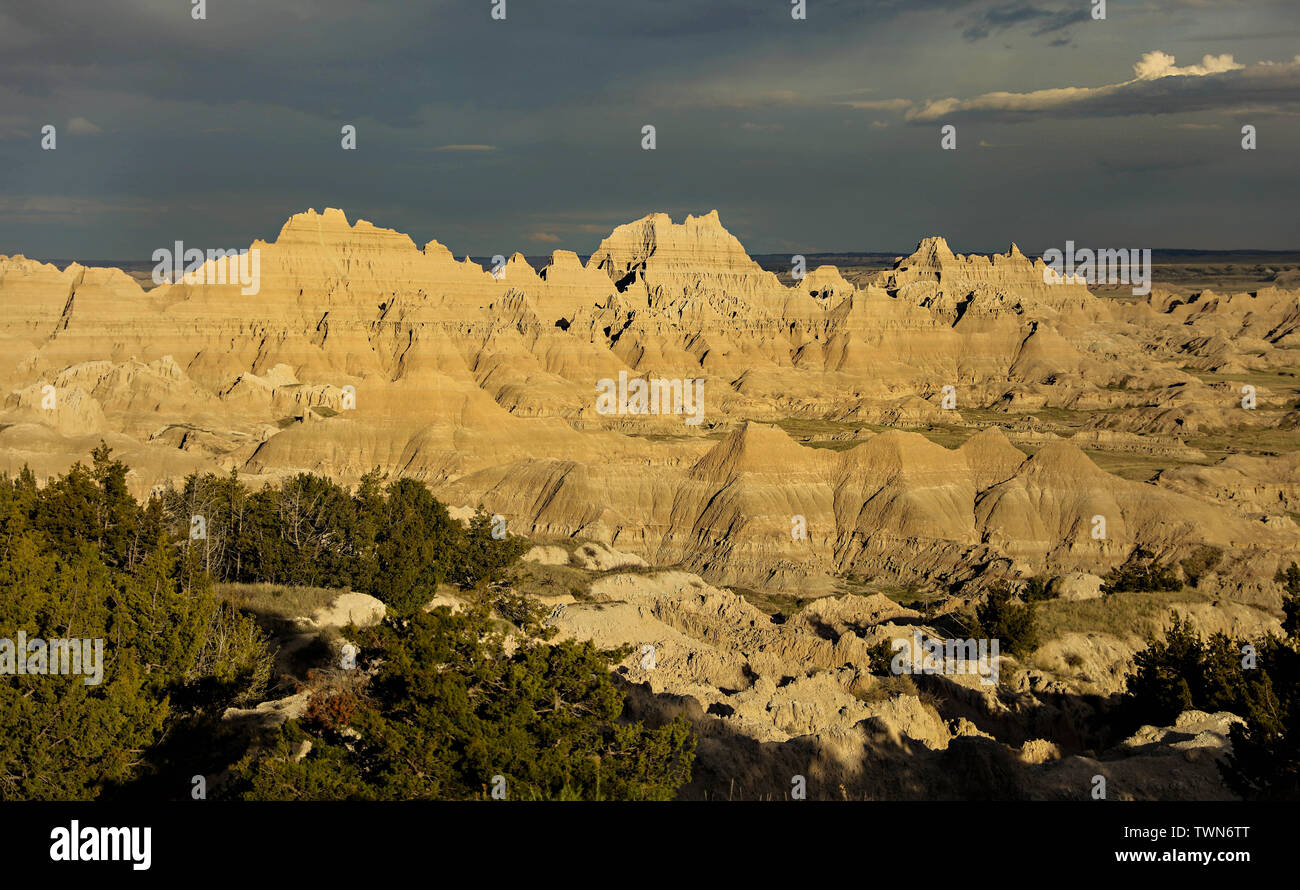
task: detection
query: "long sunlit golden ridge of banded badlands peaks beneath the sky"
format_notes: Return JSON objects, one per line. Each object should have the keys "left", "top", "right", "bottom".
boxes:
{"left": 0, "top": 209, "right": 1300, "bottom": 599}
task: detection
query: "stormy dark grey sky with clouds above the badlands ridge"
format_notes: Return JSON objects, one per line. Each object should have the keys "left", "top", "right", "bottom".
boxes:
{"left": 0, "top": 0, "right": 1300, "bottom": 261}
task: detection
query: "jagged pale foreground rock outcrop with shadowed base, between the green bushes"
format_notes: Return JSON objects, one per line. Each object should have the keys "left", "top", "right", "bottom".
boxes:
{"left": 534, "top": 566, "right": 1240, "bottom": 800}
